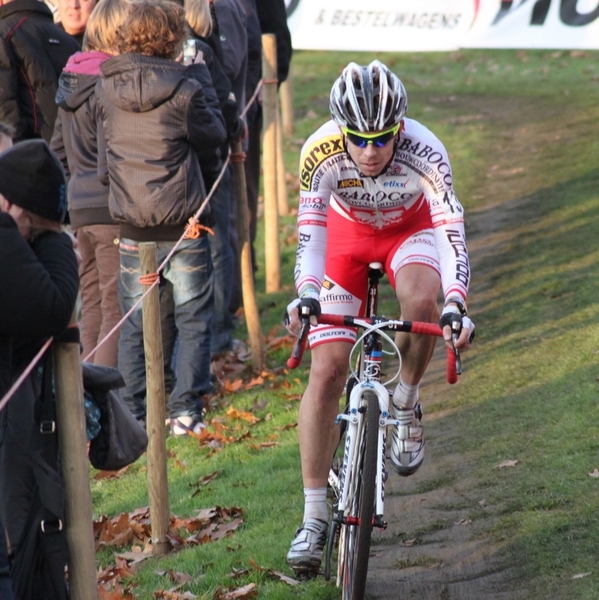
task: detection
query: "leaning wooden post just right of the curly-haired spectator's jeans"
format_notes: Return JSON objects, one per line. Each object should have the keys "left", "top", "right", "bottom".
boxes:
{"left": 231, "top": 141, "right": 264, "bottom": 371}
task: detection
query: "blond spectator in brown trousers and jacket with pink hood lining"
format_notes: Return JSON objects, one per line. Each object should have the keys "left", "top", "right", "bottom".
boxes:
{"left": 52, "top": 0, "right": 129, "bottom": 367}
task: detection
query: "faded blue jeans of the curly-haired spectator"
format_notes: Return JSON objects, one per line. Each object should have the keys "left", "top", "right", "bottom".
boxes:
{"left": 119, "top": 233, "right": 214, "bottom": 420}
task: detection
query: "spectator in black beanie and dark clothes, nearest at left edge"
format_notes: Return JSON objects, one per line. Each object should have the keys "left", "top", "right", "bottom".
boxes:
{"left": 0, "top": 140, "right": 78, "bottom": 599}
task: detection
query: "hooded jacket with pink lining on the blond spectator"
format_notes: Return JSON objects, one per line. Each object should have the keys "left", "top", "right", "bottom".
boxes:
{"left": 50, "top": 51, "right": 114, "bottom": 228}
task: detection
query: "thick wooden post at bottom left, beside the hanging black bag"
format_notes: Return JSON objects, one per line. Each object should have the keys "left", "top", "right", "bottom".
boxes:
{"left": 53, "top": 314, "right": 98, "bottom": 600}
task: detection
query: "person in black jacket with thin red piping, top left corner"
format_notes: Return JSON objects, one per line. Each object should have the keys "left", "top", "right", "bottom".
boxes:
{"left": 0, "top": 0, "right": 81, "bottom": 142}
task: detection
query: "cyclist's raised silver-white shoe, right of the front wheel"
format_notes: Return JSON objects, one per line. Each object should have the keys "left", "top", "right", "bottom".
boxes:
{"left": 391, "top": 404, "right": 424, "bottom": 477}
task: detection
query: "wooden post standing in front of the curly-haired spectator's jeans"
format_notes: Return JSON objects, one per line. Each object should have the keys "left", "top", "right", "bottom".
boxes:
{"left": 139, "top": 242, "right": 170, "bottom": 556}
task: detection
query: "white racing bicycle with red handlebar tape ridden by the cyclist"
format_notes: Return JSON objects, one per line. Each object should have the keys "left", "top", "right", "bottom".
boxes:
{"left": 287, "top": 263, "right": 461, "bottom": 600}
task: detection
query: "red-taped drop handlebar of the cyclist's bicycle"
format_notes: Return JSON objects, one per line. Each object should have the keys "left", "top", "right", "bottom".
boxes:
{"left": 287, "top": 314, "right": 461, "bottom": 383}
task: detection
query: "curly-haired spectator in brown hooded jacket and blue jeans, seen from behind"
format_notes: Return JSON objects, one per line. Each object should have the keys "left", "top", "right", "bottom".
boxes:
{"left": 97, "top": 0, "right": 226, "bottom": 435}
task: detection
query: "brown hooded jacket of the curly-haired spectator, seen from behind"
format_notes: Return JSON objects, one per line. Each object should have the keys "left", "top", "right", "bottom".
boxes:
{"left": 96, "top": 53, "right": 227, "bottom": 241}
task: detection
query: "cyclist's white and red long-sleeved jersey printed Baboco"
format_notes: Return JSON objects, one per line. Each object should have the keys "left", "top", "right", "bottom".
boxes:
{"left": 295, "top": 119, "right": 470, "bottom": 300}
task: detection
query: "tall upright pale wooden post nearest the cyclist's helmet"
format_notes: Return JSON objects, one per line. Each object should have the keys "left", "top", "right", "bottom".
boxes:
{"left": 262, "top": 33, "right": 281, "bottom": 293}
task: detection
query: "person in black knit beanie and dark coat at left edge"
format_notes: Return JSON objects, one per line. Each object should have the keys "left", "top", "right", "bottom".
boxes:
{"left": 0, "top": 140, "right": 79, "bottom": 600}
